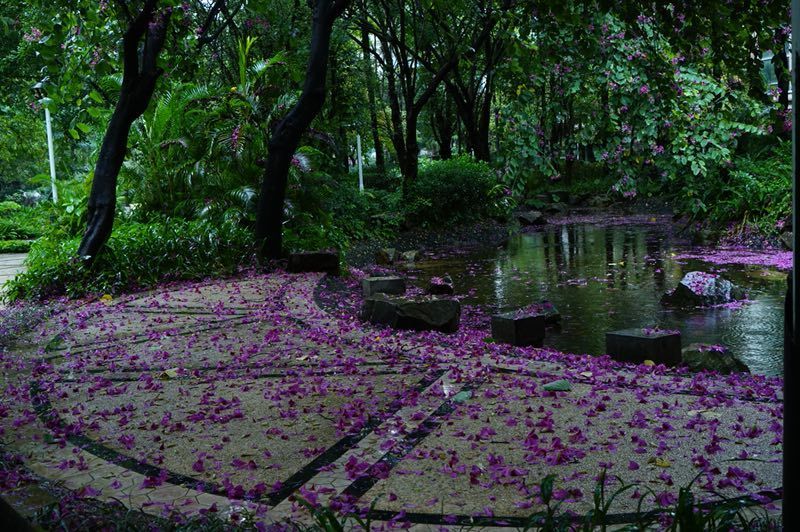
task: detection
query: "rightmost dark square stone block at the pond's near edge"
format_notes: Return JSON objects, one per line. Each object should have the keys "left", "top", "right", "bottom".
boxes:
{"left": 606, "top": 328, "right": 681, "bottom": 366}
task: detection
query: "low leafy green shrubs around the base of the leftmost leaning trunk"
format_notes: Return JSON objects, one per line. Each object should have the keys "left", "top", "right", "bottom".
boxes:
{"left": 7, "top": 219, "right": 253, "bottom": 300}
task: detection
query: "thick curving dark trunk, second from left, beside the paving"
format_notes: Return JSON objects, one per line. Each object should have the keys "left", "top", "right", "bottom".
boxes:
{"left": 255, "top": 0, "right": 349, "bottom": 262}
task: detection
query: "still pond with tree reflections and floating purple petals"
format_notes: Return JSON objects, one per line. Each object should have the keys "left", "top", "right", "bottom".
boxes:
{"left": 409, "top": 219, "right": 786, "bottom": 375}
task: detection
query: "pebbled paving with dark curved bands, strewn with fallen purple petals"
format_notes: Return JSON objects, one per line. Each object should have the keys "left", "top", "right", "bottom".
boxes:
{"left": 0, "top": 273, "right": 782, "bottom": 526}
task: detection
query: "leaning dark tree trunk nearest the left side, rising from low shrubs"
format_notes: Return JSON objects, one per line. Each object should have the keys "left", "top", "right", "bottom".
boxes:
{"left": 78, "top": 0, "right": 170, "bottom": 266}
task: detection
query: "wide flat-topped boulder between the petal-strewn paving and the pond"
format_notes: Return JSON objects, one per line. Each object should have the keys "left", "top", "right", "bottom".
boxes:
{"left": 360, "top": 294, "right": 461, "bottom": 333}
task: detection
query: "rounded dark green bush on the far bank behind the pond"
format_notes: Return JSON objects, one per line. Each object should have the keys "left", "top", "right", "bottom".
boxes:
{"left": 404, "top": 156, "right": 502, "bottom": 225}
